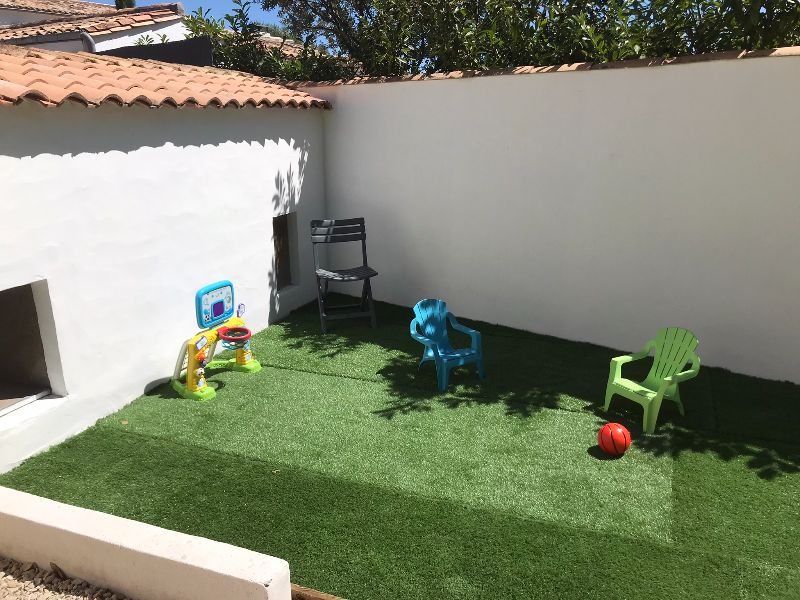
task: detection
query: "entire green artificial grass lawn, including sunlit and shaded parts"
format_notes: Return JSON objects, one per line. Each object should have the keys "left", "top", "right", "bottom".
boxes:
{"left": 0, "top": 298, "right": 800, "bottom": 600}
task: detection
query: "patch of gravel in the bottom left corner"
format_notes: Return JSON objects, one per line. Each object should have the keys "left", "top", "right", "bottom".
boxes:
{"left": 0, "top": 556, "right": 131, "bottom": 600}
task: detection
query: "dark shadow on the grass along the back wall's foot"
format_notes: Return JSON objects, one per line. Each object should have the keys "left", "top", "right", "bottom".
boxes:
{"left": 274, "top": 303, "right": 800, "bottom": 480}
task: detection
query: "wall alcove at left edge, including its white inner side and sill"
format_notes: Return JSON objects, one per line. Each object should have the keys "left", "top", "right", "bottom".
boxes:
{"left": 0, "top": 281, "right": 65, "bottom": 415}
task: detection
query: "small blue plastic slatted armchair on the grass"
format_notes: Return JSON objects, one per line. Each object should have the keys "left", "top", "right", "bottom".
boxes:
{"left": 411, "top": 299, "right": 486, "bottom": 392}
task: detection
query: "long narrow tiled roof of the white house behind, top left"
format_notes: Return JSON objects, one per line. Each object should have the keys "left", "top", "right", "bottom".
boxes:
{"left": 0, "top": 0, "right": 183, "bottom": 41}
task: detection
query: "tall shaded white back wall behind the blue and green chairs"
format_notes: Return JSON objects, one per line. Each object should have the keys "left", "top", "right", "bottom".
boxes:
{"left": 310, "top": 57, "right": 800, "bottom": 382}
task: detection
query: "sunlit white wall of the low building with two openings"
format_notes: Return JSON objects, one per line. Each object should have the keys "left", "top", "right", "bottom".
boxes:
{"left": 0, "top": 105, "right": 324, "bottom": 470}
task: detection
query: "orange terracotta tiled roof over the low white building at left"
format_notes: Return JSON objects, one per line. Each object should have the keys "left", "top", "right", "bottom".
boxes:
{"left": 0, "top": 45, "right": 329, "bottom": 108}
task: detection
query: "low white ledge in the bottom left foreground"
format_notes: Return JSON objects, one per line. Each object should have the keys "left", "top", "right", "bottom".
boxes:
{"left": 0, "top": 487, "right": 291, "bottom": 600}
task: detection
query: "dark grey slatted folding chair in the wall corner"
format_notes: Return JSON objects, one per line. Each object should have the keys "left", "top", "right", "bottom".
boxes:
{"left": 311, "top": 218, "right": 378, "bottom": 333}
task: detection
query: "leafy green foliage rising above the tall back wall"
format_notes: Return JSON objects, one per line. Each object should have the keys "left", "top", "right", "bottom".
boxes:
{"left": 188, "top": 0, "right": 800, "bottom": 79}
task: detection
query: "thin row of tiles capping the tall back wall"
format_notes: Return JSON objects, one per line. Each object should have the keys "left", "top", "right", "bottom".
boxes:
{"left": 290, "top": 46, "right": 800, "bottom": 89}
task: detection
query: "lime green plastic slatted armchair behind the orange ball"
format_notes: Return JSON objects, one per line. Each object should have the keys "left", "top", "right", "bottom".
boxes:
{"left": 603, "top": 327, "right": 700, "bottom": 433}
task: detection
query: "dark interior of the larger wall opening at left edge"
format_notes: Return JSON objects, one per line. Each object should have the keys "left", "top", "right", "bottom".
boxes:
{"left": 0, "top": 285, "right": 51, "bottom": 413}
